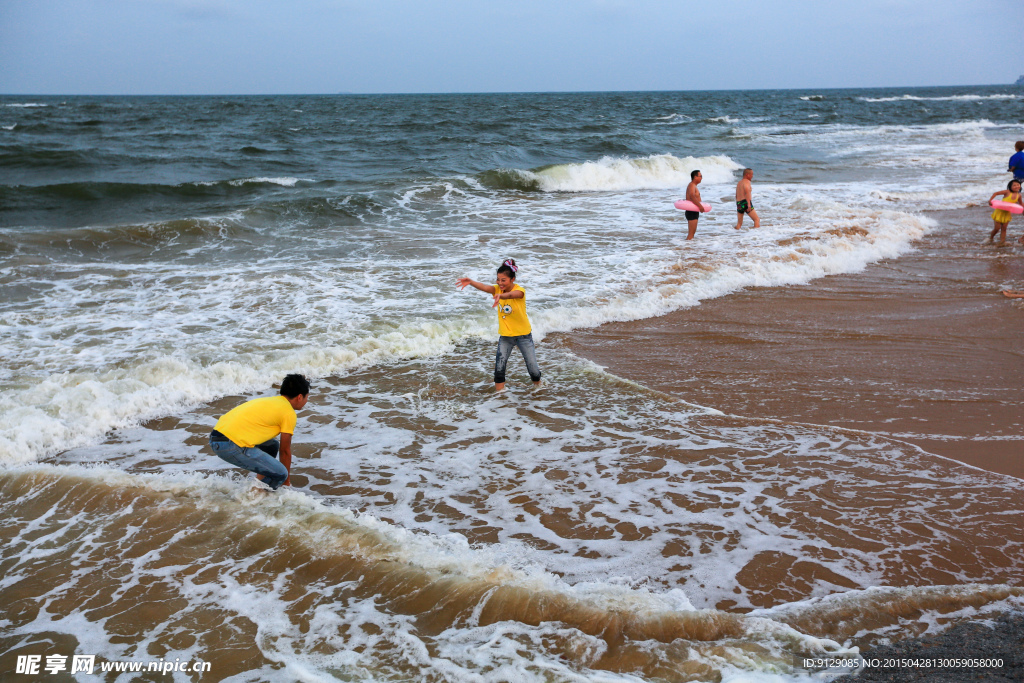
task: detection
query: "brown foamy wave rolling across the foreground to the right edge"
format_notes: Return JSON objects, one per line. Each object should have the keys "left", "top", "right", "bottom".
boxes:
{"left": 0, "top": 466, "right": 1024, "bottom": 681}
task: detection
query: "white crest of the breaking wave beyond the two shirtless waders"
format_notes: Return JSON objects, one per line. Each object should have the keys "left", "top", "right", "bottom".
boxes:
{"left": 519, "top": 155, "right": 742, "bottom": 193}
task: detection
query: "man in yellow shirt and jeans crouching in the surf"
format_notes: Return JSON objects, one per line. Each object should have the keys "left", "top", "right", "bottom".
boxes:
{"left": 204, "top": 375, "right": 309, "bottom": 489}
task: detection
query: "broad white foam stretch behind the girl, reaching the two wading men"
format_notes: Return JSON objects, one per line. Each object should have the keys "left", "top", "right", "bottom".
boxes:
{"left": 0, "top": 179, "right": 931, "bottom": 462}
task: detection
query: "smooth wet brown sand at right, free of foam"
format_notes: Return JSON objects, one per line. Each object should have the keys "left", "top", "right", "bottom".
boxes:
{"left": 550, "top": 208, "right": 1024, "bottom": 478}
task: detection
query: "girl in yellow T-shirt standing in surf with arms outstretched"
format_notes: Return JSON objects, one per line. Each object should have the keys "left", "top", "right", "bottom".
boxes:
{"left": 456, "top": 258, "right": 541, "bottom": 391}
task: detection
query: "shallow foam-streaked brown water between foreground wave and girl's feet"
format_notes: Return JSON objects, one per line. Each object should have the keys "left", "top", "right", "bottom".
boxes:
{"left": 49, "top": 350, "right": 1021, "bottom": 622}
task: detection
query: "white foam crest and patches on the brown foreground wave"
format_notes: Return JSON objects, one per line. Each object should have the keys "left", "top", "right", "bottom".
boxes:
{"left": 0, "top": 466, "right": 868, "bottom": 681}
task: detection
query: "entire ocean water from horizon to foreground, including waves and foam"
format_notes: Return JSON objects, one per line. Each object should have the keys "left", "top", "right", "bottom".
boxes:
{"left": 6, "top": 86, "right": 1024, "bottom": 681}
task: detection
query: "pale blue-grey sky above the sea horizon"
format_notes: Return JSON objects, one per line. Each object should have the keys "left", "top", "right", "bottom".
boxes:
{"left": 0, "top": 0, "right": 1024, "bottom": 95}
